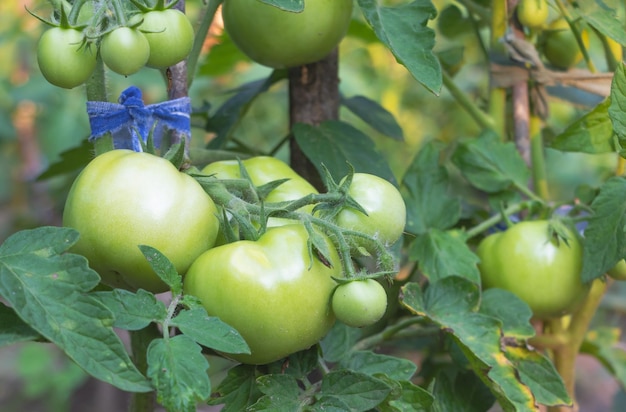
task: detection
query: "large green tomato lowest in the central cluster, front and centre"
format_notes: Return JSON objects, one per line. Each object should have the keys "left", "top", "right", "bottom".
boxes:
{"left": 184, "top": 224, "right": 341, "bottom": 364}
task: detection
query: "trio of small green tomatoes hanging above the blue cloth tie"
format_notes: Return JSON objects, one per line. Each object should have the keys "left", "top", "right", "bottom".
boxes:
{"left": 37, "top": 8, "right": 194, "bottom": 89}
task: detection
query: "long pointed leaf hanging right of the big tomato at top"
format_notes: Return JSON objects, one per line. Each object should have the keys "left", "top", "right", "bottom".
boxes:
{"left": 358, "top": 0, "right": 442, "bottom": 95}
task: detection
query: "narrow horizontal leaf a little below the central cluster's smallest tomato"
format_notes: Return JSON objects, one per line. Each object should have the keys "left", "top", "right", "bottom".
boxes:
{"left": 338, "top": 351, "right": 417, "bottom": 380}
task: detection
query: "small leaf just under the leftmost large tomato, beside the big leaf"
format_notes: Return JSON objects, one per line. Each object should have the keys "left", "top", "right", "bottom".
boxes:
{"left": 92, "top": 289, "right": 167, "bottom": 330}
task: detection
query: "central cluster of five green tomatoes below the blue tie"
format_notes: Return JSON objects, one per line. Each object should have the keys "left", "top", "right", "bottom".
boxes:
{"left": 63, "top": 150, "right": 406, "bottom": 364}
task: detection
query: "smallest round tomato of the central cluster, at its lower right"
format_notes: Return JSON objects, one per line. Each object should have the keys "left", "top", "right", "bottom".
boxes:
{"left": 332, "top": 279, "right": 387, "bottom": 328}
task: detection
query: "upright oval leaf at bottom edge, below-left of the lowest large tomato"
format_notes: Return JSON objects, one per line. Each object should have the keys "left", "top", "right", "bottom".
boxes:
{"left": 147, "top": 335, "right": 211, "bottom": 412}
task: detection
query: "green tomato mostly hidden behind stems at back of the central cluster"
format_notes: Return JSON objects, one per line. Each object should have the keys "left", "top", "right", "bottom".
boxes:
{"left": 202, "top": 156, "right": 318, "bottom": 226}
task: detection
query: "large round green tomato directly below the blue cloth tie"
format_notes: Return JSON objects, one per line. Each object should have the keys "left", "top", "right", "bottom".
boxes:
{"left": 63, "top": 150, "right": 219, "bottom": 293}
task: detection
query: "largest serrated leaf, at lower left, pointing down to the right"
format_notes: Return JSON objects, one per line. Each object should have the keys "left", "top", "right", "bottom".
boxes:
{"left": 0, "top": 227, "right": 152, "bottom": 392}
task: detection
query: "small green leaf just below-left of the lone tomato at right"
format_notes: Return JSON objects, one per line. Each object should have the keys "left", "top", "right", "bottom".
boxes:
{"left": 479, "top": 288, "right": 535, "bottom": 340}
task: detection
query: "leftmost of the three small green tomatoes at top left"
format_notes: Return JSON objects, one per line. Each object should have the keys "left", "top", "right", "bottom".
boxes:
{"left": 37, "top": 27, "right": 96, "bottom": 89}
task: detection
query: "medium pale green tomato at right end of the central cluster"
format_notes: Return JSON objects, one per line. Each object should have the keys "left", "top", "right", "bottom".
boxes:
{"left": 335, "top": 173, "right": 406, "bottom": 253}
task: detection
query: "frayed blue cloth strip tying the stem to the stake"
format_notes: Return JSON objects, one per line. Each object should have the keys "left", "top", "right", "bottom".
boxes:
{"left": 87, "top": 86, "right": 191, "bottom": 152}
